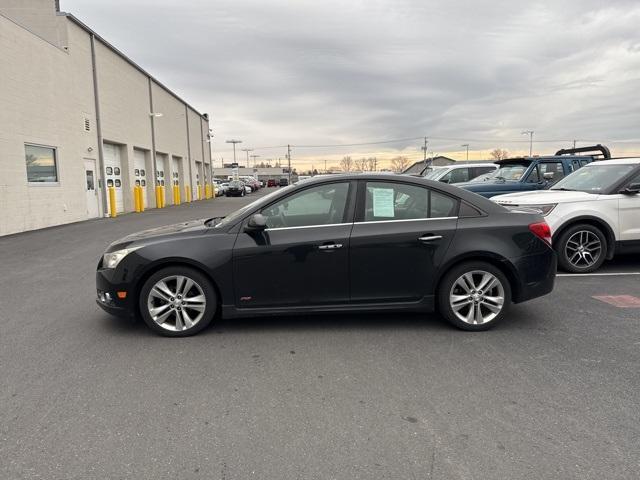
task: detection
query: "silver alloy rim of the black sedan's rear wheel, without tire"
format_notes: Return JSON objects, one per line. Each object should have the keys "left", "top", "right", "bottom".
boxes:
{"left": 449, "top": 270, "right": 505, "bottom": 325}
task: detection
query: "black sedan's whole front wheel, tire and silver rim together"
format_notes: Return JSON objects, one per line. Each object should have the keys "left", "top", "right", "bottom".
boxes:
{"left": 138, "top": 265, "right": 218, "bottom": 337}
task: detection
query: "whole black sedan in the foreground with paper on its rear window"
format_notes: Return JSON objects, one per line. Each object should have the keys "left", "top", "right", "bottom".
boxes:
{"left": 96, "top": 174, "right": 556, "bottom": 336}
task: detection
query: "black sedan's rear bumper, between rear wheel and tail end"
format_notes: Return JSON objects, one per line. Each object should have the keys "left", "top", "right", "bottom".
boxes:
{"left": 513, "top": 248, "right": 558, "bottom": 303}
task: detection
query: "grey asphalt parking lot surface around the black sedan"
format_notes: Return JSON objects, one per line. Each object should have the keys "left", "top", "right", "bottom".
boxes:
{"left": 0, "top": 191, "right": 640, "bottom": 480}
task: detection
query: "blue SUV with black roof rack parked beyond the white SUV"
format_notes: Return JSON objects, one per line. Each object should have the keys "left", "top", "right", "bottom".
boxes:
{"left": 457, "top": 145, "right": 611, "bottom": 198}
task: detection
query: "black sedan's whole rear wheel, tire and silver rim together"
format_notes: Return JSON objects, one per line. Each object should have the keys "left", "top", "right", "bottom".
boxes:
{"left": 437, "top": 261, "right": 511, "bottom": 332}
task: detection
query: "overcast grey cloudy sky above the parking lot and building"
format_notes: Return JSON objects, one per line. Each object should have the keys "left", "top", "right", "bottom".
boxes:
{"left": 61, "top": 0, "right": 640, "bottom": 169}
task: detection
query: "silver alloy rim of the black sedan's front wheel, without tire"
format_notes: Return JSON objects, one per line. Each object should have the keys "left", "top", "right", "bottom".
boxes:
{"left": 147, "top": 275, "right": 207, "bottom": 332}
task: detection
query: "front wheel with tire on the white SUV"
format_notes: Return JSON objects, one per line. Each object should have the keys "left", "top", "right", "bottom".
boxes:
{"left": 553, "top": 223, "right": 607, "bottom": 273}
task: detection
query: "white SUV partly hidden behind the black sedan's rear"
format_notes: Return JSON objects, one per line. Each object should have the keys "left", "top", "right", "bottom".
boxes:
{"left": 491, "top": 158, "right": 640, "bottom": 273}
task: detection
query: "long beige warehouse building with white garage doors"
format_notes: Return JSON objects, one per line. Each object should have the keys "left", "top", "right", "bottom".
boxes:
{"left": 0, "top": 0, "right": 211, "bottom": 235}
